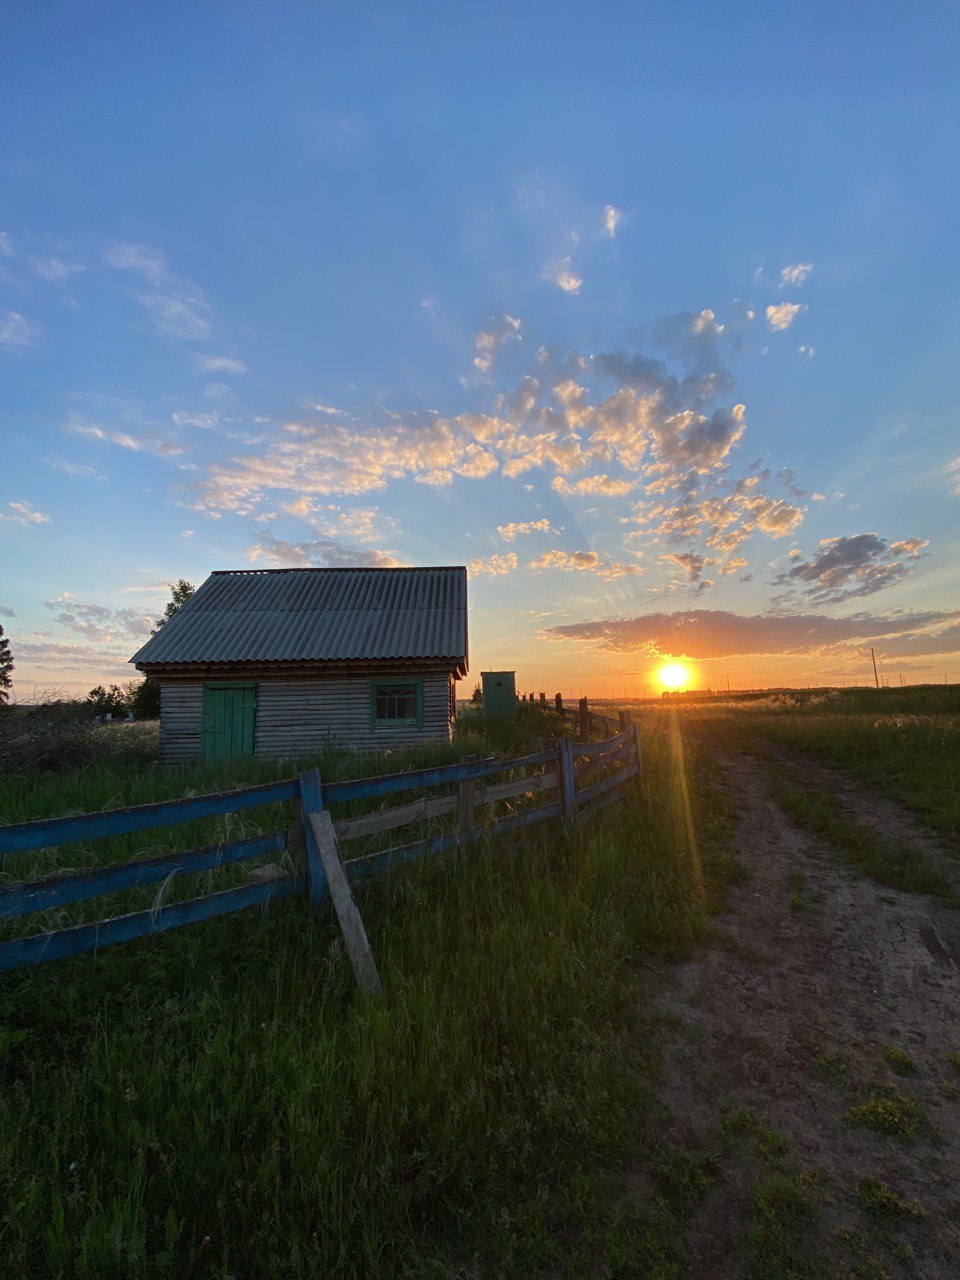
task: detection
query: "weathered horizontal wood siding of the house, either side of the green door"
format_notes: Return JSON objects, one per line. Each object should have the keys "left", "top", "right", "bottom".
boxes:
{"left": 160, "top": 669, "right": 454, "bottom": 763}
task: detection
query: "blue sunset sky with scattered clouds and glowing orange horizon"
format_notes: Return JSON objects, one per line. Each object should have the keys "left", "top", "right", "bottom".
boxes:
{"left": 0, "top": 0, "right": 960, "bottom": 701}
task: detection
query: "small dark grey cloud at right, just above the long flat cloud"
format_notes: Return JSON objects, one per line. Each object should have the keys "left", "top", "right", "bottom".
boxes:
{"left": 776, "top": 534, "right": 928, "bottom": 603}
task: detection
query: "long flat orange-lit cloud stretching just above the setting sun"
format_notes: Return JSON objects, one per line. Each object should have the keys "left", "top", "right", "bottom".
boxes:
{"left": 544, "top": 609, "right": 957, "bottom": 660}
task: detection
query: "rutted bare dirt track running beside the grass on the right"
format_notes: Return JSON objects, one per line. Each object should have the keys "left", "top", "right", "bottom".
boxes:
{"left": 655, "top": 735, "right": 960, "bottom": 1280}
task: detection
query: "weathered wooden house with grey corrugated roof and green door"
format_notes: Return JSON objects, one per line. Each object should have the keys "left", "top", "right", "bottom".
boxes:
{"left": 131, "top": 567, "right": 467, "bottom": 762}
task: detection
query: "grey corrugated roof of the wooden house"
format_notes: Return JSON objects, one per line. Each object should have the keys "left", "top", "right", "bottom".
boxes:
{"left": 131, "top": 567, "right": 467, "bottom": 664}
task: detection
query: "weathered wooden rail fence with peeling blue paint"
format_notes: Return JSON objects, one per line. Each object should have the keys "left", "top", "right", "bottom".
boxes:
{"left": 0, "top": 713, "right": 641, "bottom": 972}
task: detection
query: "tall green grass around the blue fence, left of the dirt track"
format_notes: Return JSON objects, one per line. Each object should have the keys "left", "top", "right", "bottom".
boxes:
{"left": 0, "top": 706, "right": 742, "bottom": 1280}
